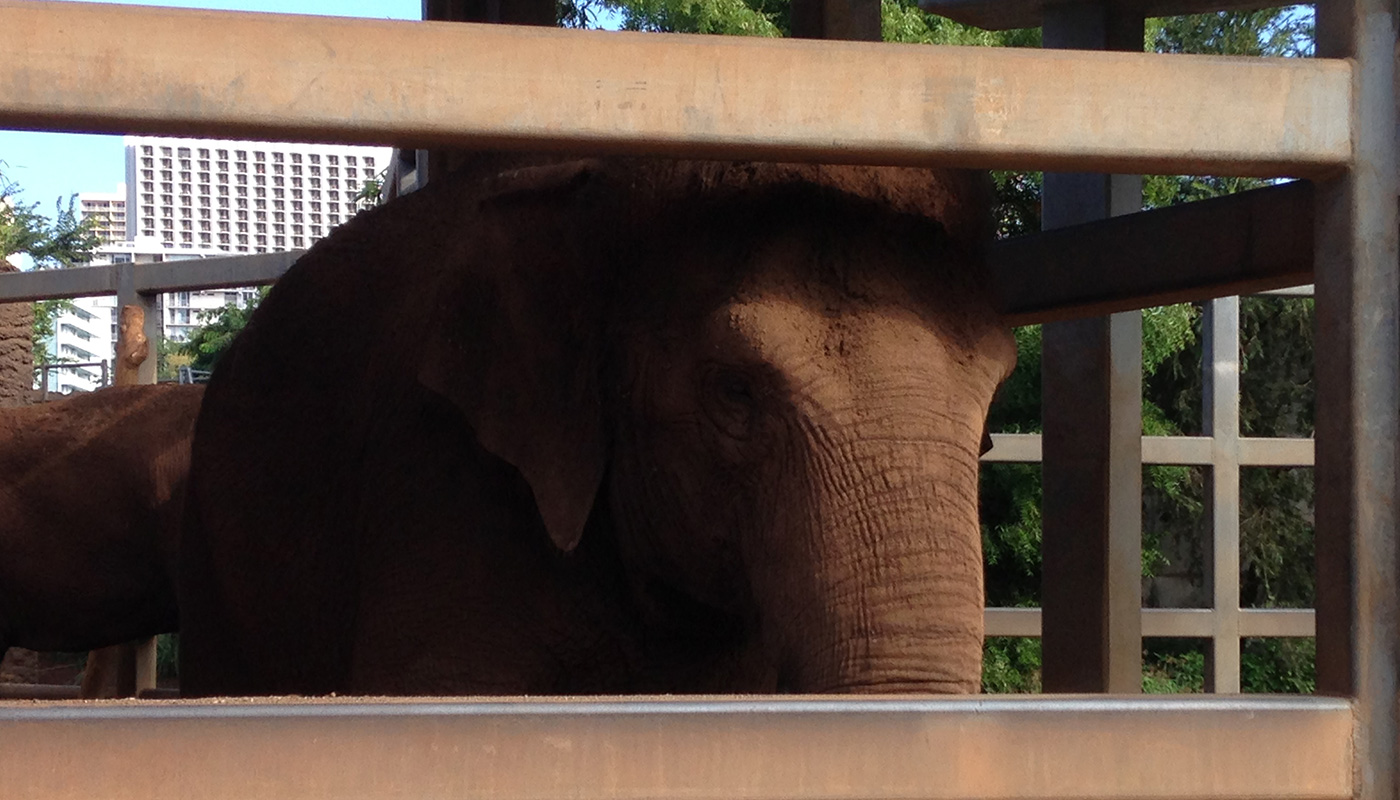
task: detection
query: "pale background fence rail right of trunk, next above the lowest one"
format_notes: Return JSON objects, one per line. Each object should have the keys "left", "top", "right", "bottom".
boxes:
{"left": 981, "top": 433, "right": 1313, "bottom": 467}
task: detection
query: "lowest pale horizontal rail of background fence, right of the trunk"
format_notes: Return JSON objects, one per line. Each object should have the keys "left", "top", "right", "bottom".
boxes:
{"left": 984, "top": 608, "right": 1316, "bottom": 639}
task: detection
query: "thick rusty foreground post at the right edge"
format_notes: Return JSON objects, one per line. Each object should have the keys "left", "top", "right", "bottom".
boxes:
{"left": 1315, "top": 0, "right": 1400, "bottom": 799}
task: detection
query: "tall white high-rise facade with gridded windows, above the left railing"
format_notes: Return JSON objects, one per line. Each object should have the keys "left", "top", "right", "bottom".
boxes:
{"left": 125, "top": 136, "right": 391, "bottom": 254}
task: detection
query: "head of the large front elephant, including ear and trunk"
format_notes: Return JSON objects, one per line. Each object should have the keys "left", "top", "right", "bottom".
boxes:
{"left": 420, "top": 160, "right": 1015, "bottom": 692}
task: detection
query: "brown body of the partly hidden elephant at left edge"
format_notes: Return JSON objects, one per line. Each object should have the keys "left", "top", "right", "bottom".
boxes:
{"left": 0, "top": 385, "right": 203, "bottom": 666}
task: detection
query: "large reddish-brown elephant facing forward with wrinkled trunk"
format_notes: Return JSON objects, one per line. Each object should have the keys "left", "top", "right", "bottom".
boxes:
{"left": 179, "top": 154, "right": 1015, "bottom": 696}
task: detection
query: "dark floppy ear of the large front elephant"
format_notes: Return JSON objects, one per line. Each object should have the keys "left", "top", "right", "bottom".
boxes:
{"left": 419, "top": 161, "right": 608, "bottom": 551}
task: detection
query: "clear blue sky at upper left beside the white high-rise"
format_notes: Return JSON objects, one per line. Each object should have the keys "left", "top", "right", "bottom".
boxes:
{"left": 0, "top": 0, "right": 423, "bottom": 217}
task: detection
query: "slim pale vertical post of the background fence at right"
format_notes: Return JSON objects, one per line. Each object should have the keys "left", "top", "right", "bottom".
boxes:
{"left": 1201, "top": 297, "right": 1239, "bottom": 692}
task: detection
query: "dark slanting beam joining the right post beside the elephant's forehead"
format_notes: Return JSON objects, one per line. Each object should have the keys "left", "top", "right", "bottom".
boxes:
{"left": 991, "top": 181, "right": 1313, "bottom": 325}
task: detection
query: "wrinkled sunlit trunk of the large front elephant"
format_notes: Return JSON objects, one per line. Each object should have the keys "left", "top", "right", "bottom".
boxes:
{"left": 767, "top": 420, "right": 983, "bottom": 694}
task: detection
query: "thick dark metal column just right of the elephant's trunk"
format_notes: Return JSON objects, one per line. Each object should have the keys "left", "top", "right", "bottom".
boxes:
{"left": 1040, "top": 3, "right": 1142, "bottom": 692}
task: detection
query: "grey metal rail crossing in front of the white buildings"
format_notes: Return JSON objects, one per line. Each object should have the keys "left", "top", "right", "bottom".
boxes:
{"left": 0, "top": 249, "right": 304, "bottom": 303}
